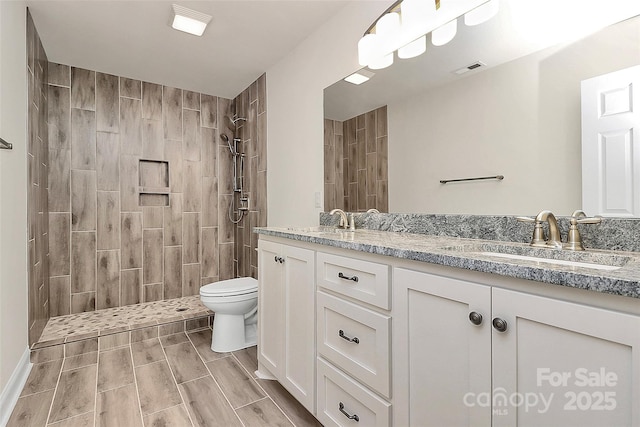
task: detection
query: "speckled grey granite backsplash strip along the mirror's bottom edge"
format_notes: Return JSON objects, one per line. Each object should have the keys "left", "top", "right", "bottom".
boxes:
{"left": 320, "top": 212, "right": 640, "bottom": 252}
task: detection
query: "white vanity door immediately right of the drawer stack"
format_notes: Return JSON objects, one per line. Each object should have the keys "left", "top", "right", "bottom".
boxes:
{"left": 392, "top": 268, "right": 491, "bottom": 427}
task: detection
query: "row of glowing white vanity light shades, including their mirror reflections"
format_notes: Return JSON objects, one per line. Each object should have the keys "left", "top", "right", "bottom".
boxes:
{"left": 358, "top": 0, "right": 499, "bottom": 70}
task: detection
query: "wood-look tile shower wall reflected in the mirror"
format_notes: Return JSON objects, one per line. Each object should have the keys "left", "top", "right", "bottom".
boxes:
{"left": 324, "top": 106, "right": 389, "bottom": 212}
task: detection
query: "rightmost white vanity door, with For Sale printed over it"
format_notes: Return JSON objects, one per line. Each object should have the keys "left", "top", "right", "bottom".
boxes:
{"left": 492, "top": 288, "right": 640, "bottom": 427}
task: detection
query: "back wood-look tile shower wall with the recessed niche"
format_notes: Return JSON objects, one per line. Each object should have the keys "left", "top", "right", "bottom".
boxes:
{"left": 49, "top": 63, "right": 268, "bottom": 316}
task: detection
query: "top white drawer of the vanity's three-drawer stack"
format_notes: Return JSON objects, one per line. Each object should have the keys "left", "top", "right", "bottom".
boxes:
{"left": 317, "top": 252, "right": 391, "bottom": 310}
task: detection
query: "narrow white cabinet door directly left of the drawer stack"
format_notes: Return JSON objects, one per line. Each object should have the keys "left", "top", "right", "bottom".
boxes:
{"left": 280, "top": 246, "right": 316, "bottom": 413}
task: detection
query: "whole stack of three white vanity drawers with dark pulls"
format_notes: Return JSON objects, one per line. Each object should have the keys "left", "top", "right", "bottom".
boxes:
{"left": 316, "top": 252, "right": 392, "bottom": 427}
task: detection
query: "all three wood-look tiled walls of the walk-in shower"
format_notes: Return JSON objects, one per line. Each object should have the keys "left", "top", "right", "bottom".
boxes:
{"left": 27, "top": 11, "right": 266, "bottom": 350}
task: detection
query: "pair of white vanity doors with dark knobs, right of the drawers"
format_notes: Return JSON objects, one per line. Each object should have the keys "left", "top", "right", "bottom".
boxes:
{"left": 393, "top": 268, "right": 640, "bottom": 427}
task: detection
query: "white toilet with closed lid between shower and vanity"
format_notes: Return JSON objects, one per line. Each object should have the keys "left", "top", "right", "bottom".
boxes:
{"left": 200, "top": 277, "right": 258, "bottom": 353}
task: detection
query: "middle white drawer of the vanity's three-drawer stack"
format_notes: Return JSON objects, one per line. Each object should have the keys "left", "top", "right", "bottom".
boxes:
{"left": 317, "top": 292, "right": 391, "bottom": 397}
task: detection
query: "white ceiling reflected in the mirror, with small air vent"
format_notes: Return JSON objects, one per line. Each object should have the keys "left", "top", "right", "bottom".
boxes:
{"left": 324, "top": 0, "right": 640, "bottom": 121}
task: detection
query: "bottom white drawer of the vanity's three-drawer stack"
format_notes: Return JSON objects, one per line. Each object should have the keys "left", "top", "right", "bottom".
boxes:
{"left": 318, "top": 359, "right": 391, "bottom": 427}
